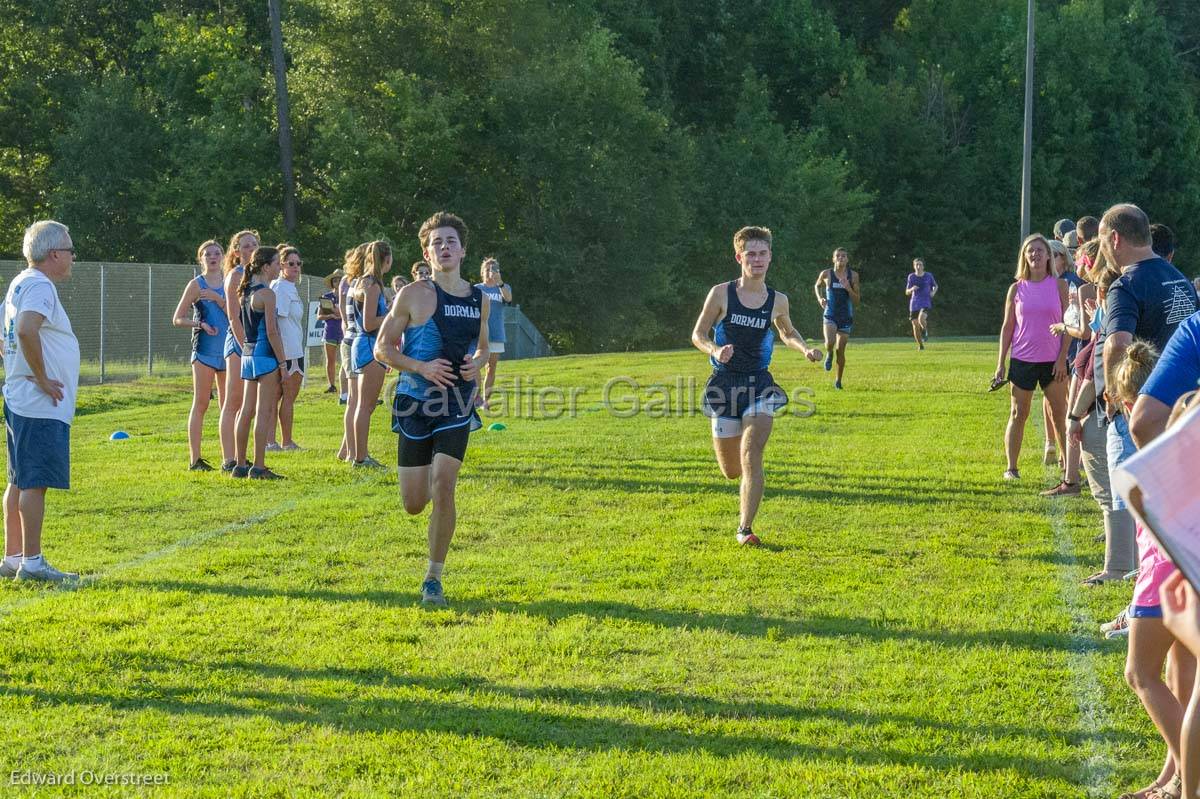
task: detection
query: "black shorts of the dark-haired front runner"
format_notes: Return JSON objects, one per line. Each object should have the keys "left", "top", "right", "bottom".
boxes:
{"left": 391, "top": 390, "right": 484, "bottom": 467}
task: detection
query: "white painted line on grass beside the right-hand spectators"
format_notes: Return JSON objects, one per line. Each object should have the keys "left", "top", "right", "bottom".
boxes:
{"left": 1050, "top": 484, "right": 1112, "bottom": 797}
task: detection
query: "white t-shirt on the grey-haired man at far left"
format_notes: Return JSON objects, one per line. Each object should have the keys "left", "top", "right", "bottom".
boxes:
{"left": 4, "top": 268, "right": 79, "bottom": 425}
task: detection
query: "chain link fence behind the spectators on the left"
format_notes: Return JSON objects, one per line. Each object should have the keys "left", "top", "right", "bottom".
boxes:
{"left": 0, "top": 260, "right": 328, "bottom": 384}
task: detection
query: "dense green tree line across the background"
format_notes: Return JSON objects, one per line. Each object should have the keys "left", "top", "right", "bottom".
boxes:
{"left": 0, "top": 0, "right": 1200, "bottom": 352}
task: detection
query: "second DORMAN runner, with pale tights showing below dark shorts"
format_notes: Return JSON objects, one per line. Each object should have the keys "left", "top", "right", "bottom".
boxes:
{"left": 691, "top": 227, "right": 821, "bottom": 546}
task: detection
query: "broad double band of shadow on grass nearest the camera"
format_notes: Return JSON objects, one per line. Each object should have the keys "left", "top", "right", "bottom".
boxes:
{"left": 0, "top": 661, "right": 1099, "bottom": 781}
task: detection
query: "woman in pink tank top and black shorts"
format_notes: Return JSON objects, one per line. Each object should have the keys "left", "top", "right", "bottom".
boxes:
{"left": 992, "top": 233, "right": 1070, "bottom": 480}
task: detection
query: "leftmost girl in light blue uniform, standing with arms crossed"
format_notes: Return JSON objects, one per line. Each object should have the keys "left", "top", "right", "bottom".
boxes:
{"left": 172, "top": 240, "right": 229, "bottom": 471}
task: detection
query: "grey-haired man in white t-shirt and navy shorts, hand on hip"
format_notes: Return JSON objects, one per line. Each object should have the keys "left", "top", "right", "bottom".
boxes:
{"left": 0, "top": 220, "right": 79, "bottom": 583}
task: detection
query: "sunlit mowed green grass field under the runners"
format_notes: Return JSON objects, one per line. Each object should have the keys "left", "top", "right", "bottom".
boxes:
{"left": 0, "top": 340, "right": 1162, "bottom": 799}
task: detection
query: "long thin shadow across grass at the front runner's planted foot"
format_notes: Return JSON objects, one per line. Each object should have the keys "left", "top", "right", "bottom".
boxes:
{"left": 127, "top": 581, "right": 1102, "bottom": 653}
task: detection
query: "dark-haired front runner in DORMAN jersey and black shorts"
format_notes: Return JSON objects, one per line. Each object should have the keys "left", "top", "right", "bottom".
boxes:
{"left": 374, "top": 211, "right": 488, "bottom": 606}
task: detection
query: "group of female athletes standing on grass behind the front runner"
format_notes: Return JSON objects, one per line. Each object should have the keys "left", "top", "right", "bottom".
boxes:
{"left": 173, "top": 230, "right": 512, "bottom": 472}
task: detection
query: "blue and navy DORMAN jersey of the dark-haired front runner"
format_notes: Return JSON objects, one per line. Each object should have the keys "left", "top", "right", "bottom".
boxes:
{"left": 396, "top": 283, "right": 484, "bottom": 400}
